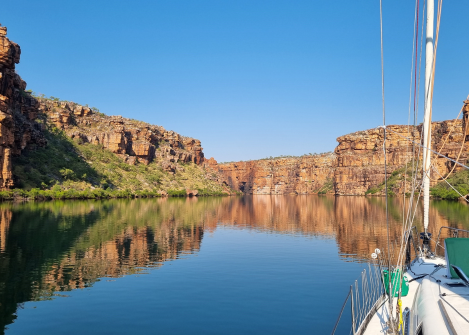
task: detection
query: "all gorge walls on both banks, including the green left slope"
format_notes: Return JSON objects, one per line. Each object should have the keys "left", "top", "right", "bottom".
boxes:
{"left": 0, "top": 23, "right": 469, "bottom": 195}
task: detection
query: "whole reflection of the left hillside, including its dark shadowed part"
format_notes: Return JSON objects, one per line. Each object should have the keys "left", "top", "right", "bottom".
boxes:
{"left": 0, "top": 199, "right": 217, "bottom": 329}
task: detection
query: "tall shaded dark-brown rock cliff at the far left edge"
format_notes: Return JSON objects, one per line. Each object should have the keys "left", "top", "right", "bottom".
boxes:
{"left": 0, "top": 26, "right": 46, "bottom": 189}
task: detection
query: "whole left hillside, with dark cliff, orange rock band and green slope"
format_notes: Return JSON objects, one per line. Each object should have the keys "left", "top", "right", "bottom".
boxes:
{"left": 0, "top": 26, "right": 231, "bottom": 198}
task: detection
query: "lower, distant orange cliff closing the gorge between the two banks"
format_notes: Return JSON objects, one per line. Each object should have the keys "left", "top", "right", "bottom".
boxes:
{"left": 217, "top": 153, "right": 335, "bottom": 194}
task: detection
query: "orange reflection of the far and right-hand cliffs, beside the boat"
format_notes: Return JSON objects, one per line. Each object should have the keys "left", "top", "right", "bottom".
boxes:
{"left": 207, "top": 196, "right": 469, "bottom": 259}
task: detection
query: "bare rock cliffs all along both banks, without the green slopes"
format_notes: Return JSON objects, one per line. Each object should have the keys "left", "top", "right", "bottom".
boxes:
{"left": 0, "top": 26, "right": 469, "bottom": 195}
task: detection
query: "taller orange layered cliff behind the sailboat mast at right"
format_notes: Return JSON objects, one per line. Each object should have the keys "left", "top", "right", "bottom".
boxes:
{"left": 334, "top": 120, "right": 469, "bottom": 195}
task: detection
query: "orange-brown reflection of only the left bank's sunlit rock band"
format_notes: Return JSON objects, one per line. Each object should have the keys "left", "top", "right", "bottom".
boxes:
{"left": 43, "top": 227, "right": 203, "bottom": 292}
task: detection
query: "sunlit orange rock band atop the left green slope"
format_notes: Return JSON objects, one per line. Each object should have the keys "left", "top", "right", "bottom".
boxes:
{"left": 39, "top": 99, "right": 204, "bottom": 172}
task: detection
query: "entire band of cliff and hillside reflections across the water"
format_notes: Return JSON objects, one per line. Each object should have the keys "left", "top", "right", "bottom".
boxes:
{"left": 0, "top": 196, "right": 469, "bottom": 329}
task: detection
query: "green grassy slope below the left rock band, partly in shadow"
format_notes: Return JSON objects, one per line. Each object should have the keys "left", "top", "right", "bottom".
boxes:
{"left": 13, "top": 126, "right": 229, "bottom": 197}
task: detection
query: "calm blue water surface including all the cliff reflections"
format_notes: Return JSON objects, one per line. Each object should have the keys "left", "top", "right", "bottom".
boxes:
{"left": 0, "top": 196, "right": 469, "bottom": 334}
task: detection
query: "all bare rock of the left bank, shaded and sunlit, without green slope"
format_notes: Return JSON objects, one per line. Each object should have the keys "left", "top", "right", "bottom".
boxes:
{"left": 0, "top": 26, "right": 212, "bottom": 189}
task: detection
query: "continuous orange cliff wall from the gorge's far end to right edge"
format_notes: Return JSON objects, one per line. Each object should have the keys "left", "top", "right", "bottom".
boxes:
{"left": 217, "top": 115, "right": 469, "bottom": 195}
